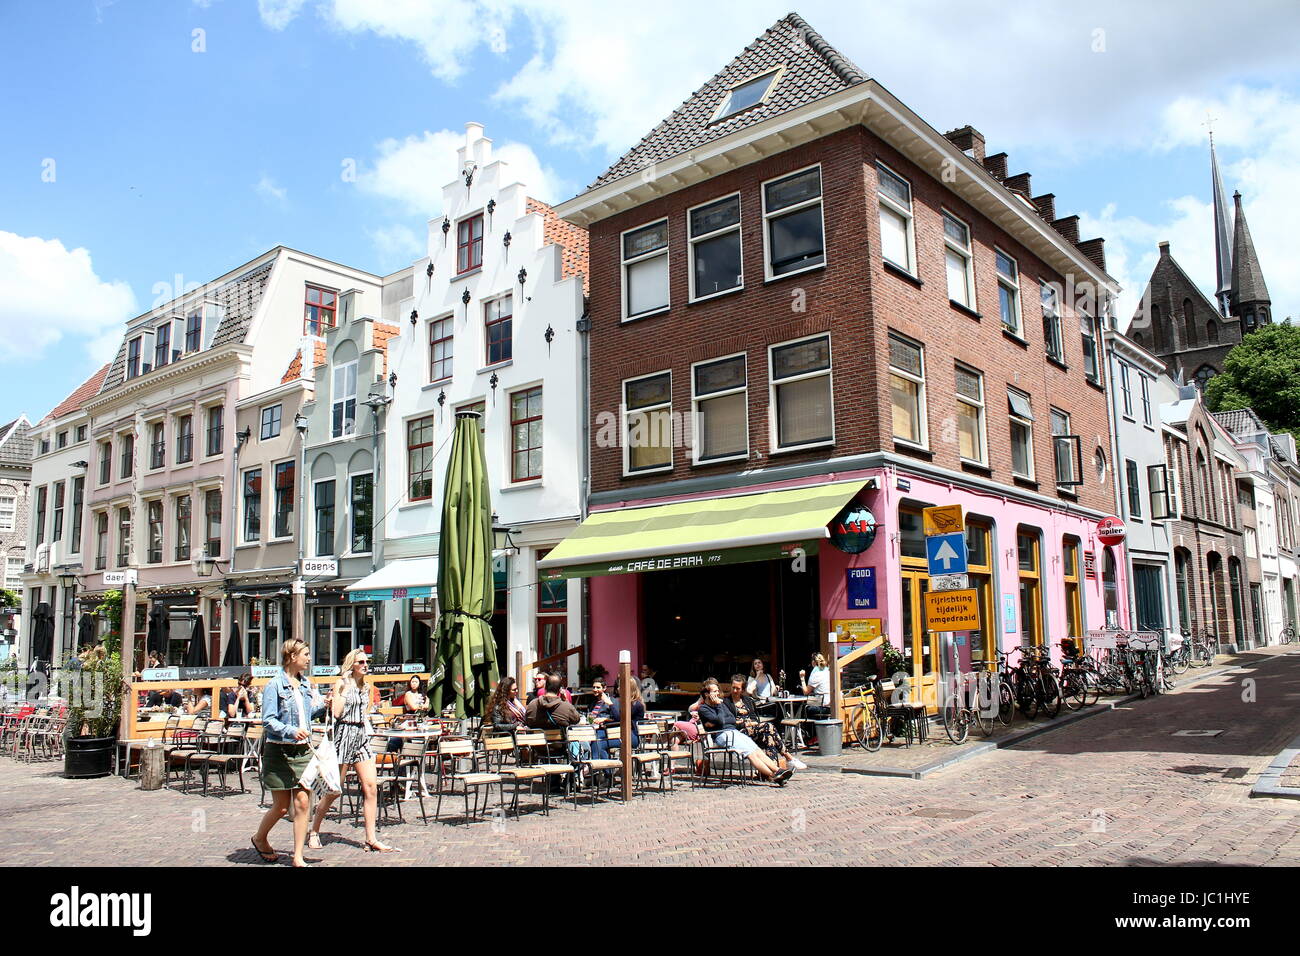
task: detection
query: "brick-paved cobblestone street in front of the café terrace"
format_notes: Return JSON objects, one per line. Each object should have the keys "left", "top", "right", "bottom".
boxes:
{"left": 10, "top": 653, "right": 1300, "bottom": 866}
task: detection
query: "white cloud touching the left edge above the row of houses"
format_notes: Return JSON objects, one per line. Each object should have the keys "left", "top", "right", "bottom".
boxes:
{"left": 0, "top": 232, "right": 138, "bottom": 362}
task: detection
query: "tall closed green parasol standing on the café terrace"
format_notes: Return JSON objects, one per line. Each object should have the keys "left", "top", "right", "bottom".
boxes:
{"left": 429, "top": 411, "right": 497, "bottom": 717}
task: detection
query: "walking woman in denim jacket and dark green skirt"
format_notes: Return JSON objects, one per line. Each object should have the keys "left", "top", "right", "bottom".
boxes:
{"left": 252, "top": 640, "right": 328, "bottom": 866}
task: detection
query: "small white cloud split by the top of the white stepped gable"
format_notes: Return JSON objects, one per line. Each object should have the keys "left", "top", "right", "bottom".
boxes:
{"left": 358, "top": 130, "right": 559, "bottom": 219}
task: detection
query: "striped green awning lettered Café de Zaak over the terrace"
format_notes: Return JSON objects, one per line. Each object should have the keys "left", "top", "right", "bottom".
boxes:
{"left": 538, "top": 479, "right": 875, "bottom": 580}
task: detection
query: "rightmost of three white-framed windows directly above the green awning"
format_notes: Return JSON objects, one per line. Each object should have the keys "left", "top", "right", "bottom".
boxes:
{"left": 768, "top": 336, "right": 835, "bottom": 450}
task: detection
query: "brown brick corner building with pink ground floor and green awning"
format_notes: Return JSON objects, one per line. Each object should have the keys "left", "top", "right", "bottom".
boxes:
{"left": 542, "top": 14, "right": 1127, "bottom": 683}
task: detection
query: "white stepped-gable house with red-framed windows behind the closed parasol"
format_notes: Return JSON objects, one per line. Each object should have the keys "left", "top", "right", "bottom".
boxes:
{"left": 379, "top": 122, "right": 586, "bottom": 680}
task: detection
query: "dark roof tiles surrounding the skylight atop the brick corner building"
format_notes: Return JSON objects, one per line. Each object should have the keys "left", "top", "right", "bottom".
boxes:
{"left": 588, "top": 13, "right": 866, "bottom": 189}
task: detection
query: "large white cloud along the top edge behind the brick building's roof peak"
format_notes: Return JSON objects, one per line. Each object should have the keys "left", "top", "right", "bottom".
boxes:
{"left": 260, "top": 0, "right": 1300, "bottom": 159}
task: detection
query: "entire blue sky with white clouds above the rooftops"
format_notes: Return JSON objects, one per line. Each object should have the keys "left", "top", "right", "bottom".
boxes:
{"left": 0, "top": 0, "right": 1300, "bottom": 420}
